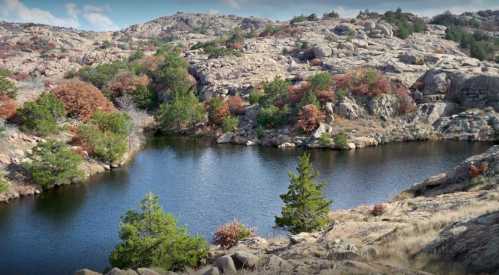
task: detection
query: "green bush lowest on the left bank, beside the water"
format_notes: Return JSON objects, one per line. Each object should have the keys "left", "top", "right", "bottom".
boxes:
{"left": 23, "top": 140, "right": 83, "bottom": 189}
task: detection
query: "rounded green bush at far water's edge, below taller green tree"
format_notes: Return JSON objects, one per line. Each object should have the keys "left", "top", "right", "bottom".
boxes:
{"left": 157, "top": 91, "right": 206, "bottom": 132}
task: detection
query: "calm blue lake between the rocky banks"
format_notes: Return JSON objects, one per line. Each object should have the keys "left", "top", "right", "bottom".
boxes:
{"left": 0, "top": 138, "right": 491, "bottom": 275}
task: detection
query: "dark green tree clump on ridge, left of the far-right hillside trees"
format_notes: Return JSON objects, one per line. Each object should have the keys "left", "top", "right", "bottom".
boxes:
{"left": 383, "top": 8, "right": 426, "bottom": 39}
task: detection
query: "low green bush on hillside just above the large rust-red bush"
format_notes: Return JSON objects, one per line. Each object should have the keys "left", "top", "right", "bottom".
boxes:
{"left": 78, "top": 61, "right": 128, "bottom": 89}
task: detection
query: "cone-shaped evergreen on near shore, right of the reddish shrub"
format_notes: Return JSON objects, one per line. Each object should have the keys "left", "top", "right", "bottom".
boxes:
{"left": 275, "top": 154, "right": 332, "bottom": 234}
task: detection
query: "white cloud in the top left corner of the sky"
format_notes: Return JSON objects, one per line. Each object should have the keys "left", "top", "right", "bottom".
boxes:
{"left": 0, "top": 0, "right": 80, "bottom": 28}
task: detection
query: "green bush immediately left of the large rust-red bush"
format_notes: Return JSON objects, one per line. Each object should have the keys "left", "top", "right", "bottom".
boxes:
{"left": 18, "top": 93, "right": 64, "bottom": 136}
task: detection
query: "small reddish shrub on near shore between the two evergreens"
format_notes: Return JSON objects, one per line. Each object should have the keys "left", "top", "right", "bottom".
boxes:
{"left": 213, "top": 220, "right": 255, "bottom": 249}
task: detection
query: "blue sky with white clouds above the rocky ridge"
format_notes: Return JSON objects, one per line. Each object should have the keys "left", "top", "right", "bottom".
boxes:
{"left": 0, "top": 0, "right": 499, "bottom": 31}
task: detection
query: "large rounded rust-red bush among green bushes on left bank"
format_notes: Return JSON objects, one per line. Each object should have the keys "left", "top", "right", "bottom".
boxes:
{"left": 53, "top": 80, "right": 115, "bottom": 120}
